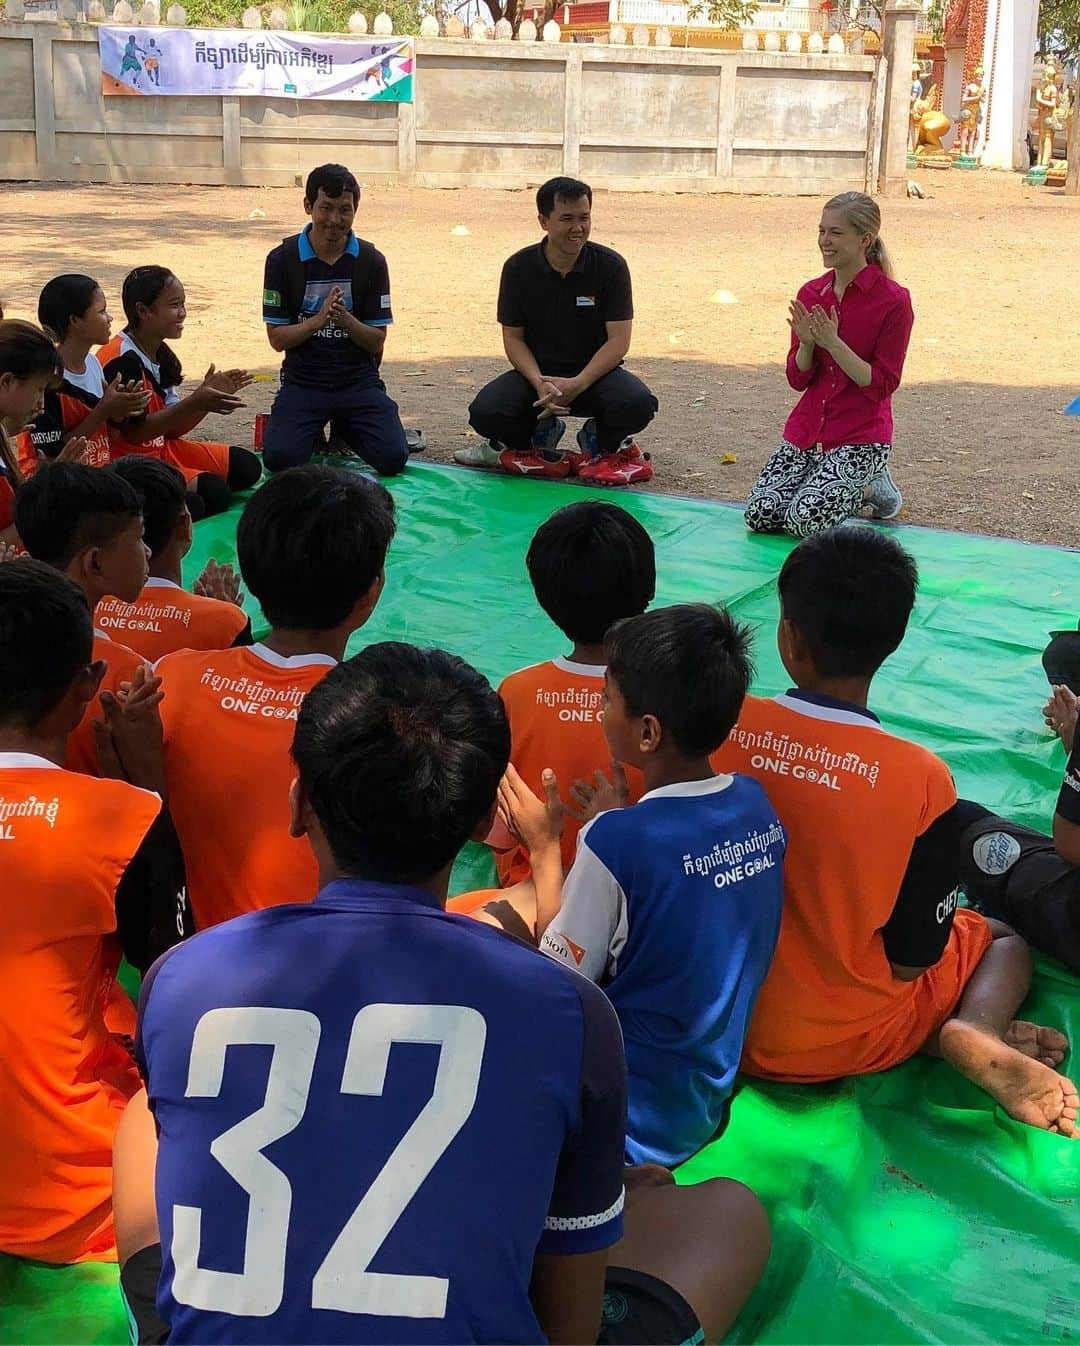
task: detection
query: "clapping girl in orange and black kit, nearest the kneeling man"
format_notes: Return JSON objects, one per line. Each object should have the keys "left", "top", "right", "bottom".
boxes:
{"left": 98, "top": 267, "right": 263, "bottom": 514}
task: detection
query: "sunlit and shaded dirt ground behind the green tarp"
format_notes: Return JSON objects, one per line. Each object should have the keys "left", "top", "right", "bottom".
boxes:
{"left": 0, "top": 171, "right": 1080, "bottom": 546}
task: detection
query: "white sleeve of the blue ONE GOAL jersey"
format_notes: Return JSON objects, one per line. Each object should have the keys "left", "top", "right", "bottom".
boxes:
{"left": 540, "top": 818, "right": 628, "bottom": 981}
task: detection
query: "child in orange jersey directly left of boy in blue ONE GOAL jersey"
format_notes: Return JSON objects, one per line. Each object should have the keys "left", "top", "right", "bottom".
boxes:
{"left": 489, "top": 501, "right": 656, "bottom": 887}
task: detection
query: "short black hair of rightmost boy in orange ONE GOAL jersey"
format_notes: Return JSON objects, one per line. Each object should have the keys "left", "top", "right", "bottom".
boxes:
{"left": 778, "top": 526, "right": 918, "bottom": 677}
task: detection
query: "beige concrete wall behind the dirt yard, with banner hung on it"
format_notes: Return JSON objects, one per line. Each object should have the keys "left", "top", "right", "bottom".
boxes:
{"left": 0, "top": 23, "right": 883, "bottom": 195}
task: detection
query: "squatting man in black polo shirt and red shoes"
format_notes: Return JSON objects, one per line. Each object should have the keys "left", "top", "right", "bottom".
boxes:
{"left": 454, "top": 178, "right": 657, "bottom": 486}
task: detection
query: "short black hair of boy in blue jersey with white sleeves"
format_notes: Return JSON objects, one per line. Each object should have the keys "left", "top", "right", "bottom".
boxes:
{"left": 605, "top": 603, "right": 754, "bottom": 758}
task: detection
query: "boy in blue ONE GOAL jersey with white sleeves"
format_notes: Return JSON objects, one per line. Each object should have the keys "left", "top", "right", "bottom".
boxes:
{"left": 537, "top": 604, "right": 786, "bottom": 1166}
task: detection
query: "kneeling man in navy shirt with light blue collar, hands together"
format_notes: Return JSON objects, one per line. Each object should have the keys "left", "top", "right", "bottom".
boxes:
{"left": 263, "top": 164, "right": 409, "bottom": 475}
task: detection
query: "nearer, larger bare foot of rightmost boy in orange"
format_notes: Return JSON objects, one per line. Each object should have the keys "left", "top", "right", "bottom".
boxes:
{"left": 939, "top": 1019, "right": 1080, "bottom": 1137}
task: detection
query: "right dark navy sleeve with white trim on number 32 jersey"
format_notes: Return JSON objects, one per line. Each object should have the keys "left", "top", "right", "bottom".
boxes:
{"left": 536, "top": 979, "right": 626, "bottom": 1256}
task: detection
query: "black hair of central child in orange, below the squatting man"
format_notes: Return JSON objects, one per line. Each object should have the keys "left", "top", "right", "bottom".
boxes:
{"left": 525, "top": 501, "right": 656, "bottom": 645}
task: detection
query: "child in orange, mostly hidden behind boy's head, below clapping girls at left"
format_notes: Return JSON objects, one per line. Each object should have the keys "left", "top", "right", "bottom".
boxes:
{"left": 94, "top": 455, "right": 252, "bottom": 664}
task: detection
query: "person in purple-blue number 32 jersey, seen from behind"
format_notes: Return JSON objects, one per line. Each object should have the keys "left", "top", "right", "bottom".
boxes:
{"left": 114, "top": 643, "right": 769, "bottom": 1343}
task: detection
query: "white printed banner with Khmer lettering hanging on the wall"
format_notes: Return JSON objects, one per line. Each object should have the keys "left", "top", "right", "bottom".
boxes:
{"left": 97, "top": 27, "right": 416, "bottom": 102}
